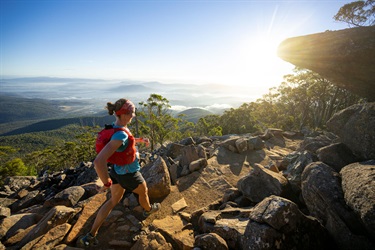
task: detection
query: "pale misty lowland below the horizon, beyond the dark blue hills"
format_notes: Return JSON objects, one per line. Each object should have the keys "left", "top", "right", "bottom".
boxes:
{"left": 0, "top": 77, "right": 253, "bottom": 112}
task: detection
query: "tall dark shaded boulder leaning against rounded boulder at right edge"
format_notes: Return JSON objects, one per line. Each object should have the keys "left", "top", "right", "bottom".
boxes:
{"left": 302, "top": 162, "right": 373, "bottom": 250}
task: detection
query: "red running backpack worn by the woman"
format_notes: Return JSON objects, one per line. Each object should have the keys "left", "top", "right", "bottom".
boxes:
{"left": 95, "top": 124, "right": 137, "bottom": 165}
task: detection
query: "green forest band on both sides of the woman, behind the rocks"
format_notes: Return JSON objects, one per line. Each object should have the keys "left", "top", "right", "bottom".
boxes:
{"left": 0, "top": 68, "right": 366, "bottom": 182}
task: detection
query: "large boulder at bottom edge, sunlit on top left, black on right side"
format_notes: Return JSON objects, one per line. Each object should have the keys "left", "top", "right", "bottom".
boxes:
{"left": 242, "top": 195, "right": 335, "bottom": 250}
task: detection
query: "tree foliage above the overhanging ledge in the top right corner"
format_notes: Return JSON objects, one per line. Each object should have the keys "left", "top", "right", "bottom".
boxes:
{"left": 333, "top": 0, "right": 375, "bottom": 27}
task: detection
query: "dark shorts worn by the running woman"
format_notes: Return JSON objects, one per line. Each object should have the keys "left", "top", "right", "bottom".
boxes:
{"left": 109, "top": 168, "right": 145, "bottom": 192}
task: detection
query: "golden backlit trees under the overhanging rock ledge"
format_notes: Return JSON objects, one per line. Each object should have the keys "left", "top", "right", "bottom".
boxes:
{"left": 219, "top": 68, "right": 361, "bottom": 134}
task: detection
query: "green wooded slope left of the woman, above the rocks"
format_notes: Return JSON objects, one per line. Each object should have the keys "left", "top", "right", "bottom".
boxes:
{"left": 0, "top": 125, "right": 100, "bottom": 175}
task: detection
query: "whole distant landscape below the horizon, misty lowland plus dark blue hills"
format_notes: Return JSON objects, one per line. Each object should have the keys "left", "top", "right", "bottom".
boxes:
{"left": 0, "top": 77, "right": 256, "bottom": 135}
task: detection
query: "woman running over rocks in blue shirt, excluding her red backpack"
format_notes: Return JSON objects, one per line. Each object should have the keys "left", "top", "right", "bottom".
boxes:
{"left": 77, "top": 99, "right": 160, "bottom": 247}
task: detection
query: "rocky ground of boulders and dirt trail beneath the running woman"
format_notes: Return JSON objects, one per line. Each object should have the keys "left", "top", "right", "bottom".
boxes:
{"left": 0, "top": 122, "right": 375, "bottom": 250}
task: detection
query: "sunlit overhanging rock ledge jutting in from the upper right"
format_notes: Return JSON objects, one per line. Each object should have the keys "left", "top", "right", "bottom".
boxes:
{"left": 278, "top": 26, "right": 375, "bottom": 101}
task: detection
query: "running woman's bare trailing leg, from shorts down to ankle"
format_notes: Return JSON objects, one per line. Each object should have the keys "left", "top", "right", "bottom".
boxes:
{"left": 90, "top": 184, "right": 125, "bottom": 236}
